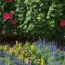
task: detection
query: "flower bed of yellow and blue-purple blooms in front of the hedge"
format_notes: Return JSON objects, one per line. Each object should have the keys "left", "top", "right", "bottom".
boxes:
{"left": 0, "top": 40, "right": 65, "bottom": 65}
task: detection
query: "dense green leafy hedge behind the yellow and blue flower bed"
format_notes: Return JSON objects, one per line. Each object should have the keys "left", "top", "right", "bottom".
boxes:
{"left": 0, "top": 0, "right": 65, "bottom": 44}
